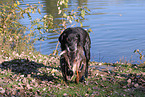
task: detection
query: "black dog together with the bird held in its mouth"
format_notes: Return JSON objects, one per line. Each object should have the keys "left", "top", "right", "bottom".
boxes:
{"left": 59, "top": 27, "right": 91, "bottom": 83}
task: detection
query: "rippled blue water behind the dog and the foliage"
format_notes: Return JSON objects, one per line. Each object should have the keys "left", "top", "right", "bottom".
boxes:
{"left": 15, "top": 0, "right": 145, "bottom": 63}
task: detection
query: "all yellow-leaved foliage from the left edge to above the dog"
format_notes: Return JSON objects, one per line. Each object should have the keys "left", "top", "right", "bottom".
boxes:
{"left": 0, "top": 0, "right": 89, "bottom": 57}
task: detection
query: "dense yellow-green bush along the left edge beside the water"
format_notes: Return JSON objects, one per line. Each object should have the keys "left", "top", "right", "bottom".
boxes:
{"left": 0, "top": 1, "right": 38, "bottom": 57}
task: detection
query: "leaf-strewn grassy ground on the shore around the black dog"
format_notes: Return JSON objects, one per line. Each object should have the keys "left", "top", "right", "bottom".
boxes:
{"left": 0, "top": 53, "right": 145, "bottom": 97}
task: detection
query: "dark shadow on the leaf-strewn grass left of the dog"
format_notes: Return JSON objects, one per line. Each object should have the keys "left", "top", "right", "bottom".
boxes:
{"left": 0, "top": 59, "right": 60, "bottom": 81}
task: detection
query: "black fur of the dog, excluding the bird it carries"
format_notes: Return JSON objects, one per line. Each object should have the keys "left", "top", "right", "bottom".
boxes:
{"left": 59, "top": 27, "right": 91, "bottom": 81}
